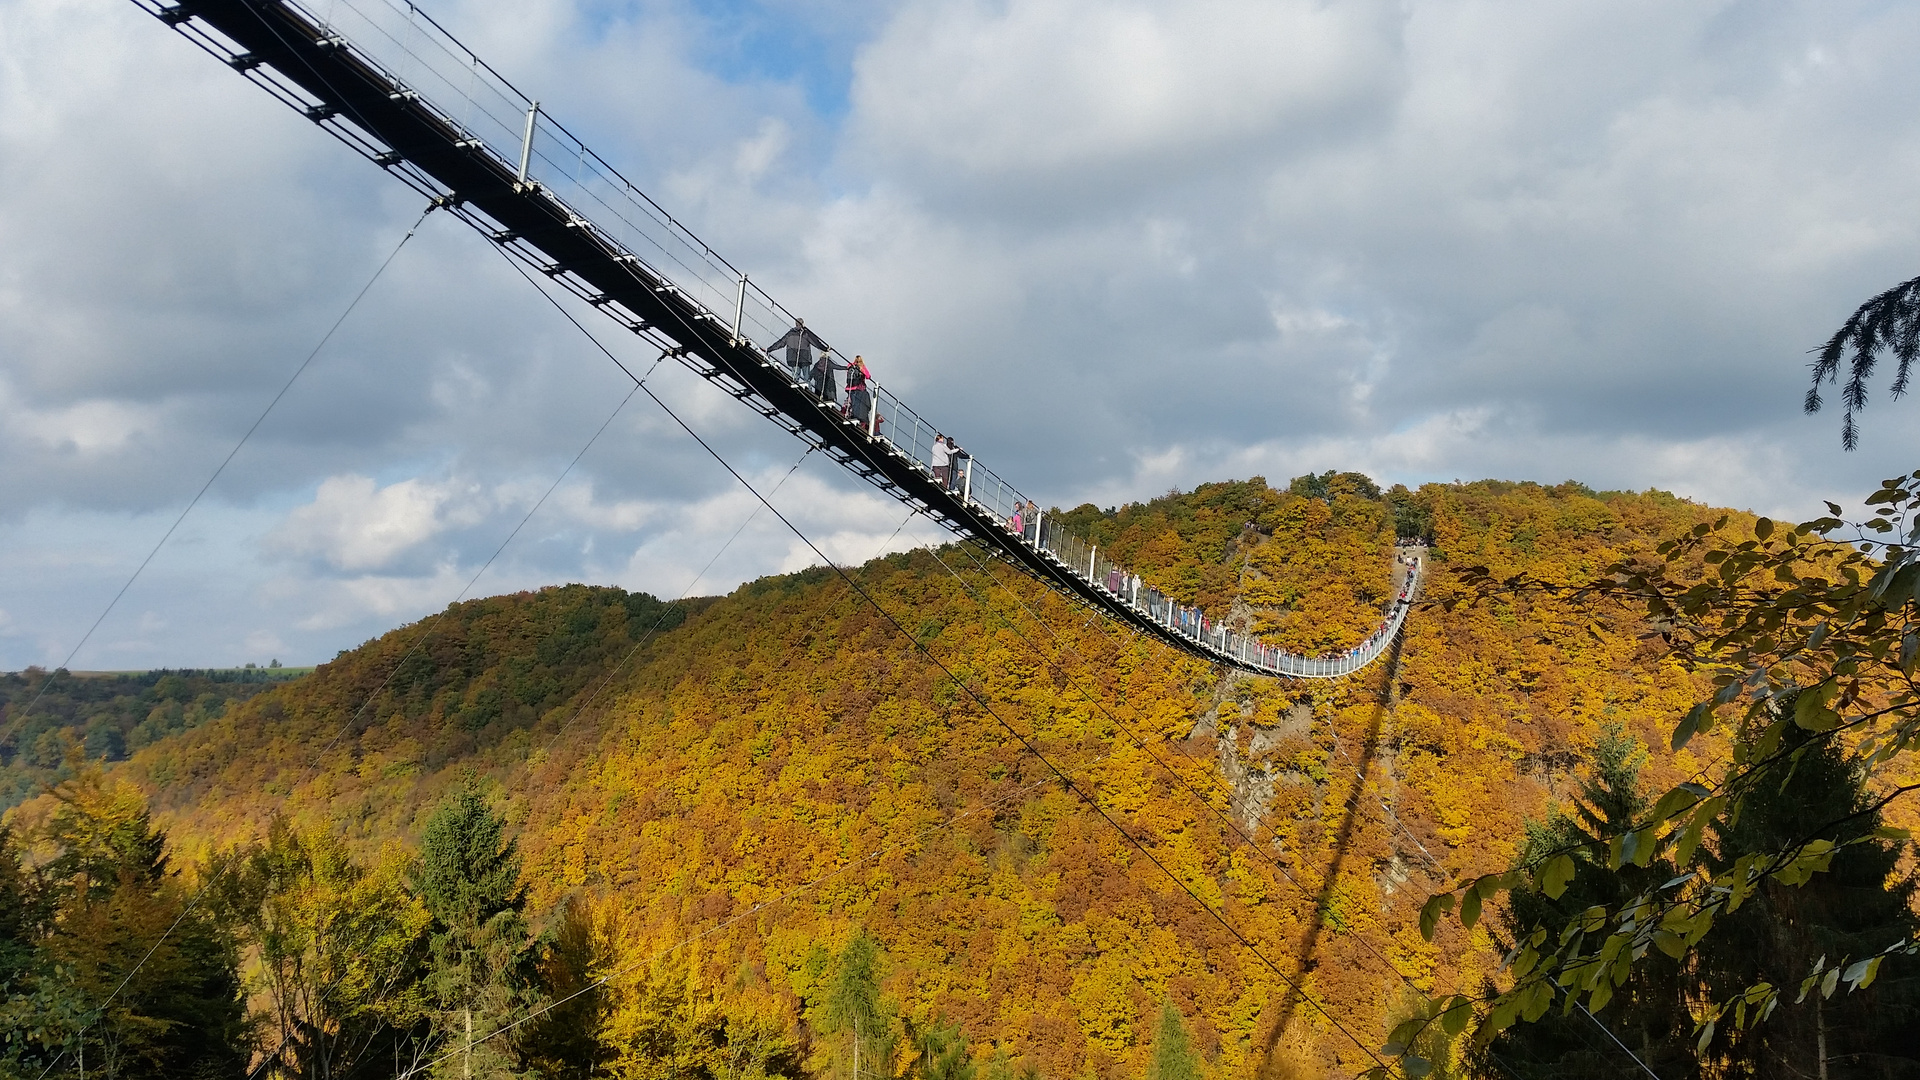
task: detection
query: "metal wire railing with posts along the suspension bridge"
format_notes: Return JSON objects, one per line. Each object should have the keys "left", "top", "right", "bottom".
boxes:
{"left": 157, "top": 0, "right": 1425, "bottom": 678}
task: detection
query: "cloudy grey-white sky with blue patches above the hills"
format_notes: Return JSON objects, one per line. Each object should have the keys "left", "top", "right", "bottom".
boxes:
{"left": 0, "top": 0, "right": 1920, "bottom": 669}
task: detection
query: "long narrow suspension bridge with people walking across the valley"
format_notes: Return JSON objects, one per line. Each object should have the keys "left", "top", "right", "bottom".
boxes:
{"left": 134, "top": 0, "right": 1425, "bottom": 678}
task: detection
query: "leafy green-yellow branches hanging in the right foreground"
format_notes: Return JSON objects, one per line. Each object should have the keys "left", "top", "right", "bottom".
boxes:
{"left": 1375, "top": 471, "right": 1920, "bottom": 1076}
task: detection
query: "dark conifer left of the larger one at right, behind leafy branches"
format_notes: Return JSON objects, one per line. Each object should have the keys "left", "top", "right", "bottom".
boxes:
{"left": 1478, "top": 723, "right": 1695, "bottom": 1080}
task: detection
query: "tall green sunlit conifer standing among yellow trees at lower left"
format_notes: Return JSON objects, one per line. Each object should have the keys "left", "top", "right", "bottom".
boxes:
{"left": 413, "top": 784, "right": 536, "bottom": 1080}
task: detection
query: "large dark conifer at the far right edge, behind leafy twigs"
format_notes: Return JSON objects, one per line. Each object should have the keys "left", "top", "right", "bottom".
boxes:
{"left": 1699, "top": 705, "right": 1920, "bottom": 1080}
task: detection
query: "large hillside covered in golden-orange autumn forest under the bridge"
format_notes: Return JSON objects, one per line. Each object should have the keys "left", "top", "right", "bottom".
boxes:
{"left": 10, "top": 473, "right": 1866, "bottom": 1080}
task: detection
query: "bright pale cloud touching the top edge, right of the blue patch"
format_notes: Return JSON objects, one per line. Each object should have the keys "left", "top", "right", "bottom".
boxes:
{"left": 852, "top": 0, "right": 1405, "bottom": 186}
